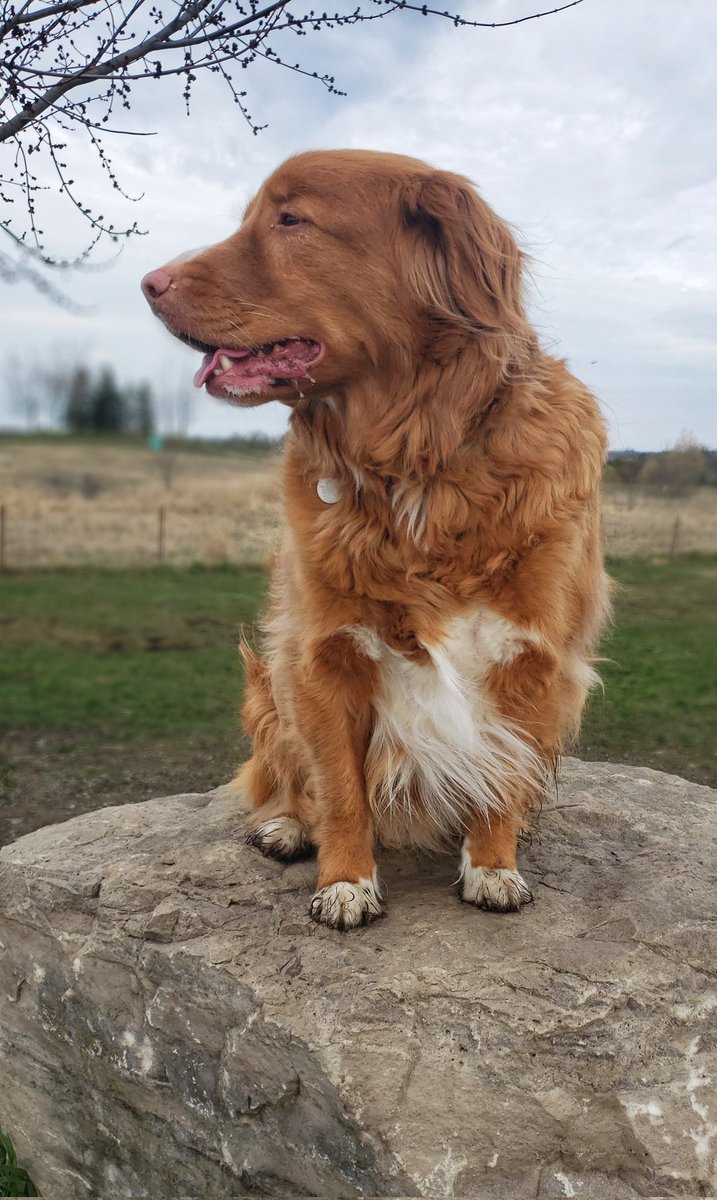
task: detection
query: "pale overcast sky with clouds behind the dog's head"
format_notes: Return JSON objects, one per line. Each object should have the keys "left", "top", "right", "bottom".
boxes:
{"left": 0, "top": 0, "right": 717, "bottom": 449}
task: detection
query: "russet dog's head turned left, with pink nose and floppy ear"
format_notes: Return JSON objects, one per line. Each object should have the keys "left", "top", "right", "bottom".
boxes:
{"left": 143, "top": 150, "right": 530, "bottom": 404}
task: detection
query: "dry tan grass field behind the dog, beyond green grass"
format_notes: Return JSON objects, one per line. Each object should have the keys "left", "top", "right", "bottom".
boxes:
{"left": 0, "top": 439, "right": 717, "bottom": 566}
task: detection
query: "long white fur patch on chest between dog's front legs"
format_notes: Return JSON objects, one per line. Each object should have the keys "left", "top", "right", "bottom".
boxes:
{"left": 350, "top": 607, "right": 541, "bottom": 845}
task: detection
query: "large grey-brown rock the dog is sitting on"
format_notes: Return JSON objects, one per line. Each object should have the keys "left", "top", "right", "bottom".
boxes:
{"left": 0, "top": 762, "right": 717, "bottom": 1200}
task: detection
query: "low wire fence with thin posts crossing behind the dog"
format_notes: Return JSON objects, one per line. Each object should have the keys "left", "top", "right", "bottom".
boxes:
{"left": 0, "top": 487, "right": 717, "bottom": 570}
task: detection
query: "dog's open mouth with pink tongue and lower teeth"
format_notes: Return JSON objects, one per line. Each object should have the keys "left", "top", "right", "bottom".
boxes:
{"left": 194, "top": 337, "right": 324, "bottom": 391}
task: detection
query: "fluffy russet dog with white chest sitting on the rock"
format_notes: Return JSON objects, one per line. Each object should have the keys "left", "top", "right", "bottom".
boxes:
{"left": 143, "top": 150, "right": 608, "bottom": 930}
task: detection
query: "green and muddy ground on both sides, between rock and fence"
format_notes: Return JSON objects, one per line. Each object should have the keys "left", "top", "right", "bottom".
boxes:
{"left": 0, "top": 556, "right": 717, "bottom": 842}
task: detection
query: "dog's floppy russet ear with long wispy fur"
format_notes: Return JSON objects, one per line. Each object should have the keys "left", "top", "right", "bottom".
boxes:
{"left": 404, "top": 170, "right": 534, "bottom": 361}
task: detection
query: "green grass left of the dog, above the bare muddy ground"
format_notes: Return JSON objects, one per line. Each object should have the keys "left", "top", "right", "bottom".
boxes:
{"left": 0, "top": 569, "right": 266, "bottom": 739}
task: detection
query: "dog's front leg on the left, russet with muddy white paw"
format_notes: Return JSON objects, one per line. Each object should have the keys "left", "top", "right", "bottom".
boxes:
{"left": 296, "top": 631, "right": 382, "bottom": 930}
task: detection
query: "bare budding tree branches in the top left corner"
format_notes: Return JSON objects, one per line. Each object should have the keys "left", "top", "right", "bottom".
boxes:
{"left": 0, "top": 0, "right": 584, "bottom": 283}
